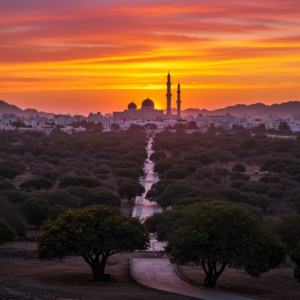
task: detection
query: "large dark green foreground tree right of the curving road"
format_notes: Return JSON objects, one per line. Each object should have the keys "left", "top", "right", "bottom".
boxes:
{"left": 165, "top": 202, "right": 286, "bottom": 288}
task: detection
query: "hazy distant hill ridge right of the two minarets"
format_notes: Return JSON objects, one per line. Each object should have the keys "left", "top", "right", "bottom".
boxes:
{"left": 165, "top": 101, "right": 300, "bottom": 118}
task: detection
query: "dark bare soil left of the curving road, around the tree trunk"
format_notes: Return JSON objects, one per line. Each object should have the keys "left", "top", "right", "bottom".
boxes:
{"left": 0, "top": 242, "right": 189, "bottom": 300}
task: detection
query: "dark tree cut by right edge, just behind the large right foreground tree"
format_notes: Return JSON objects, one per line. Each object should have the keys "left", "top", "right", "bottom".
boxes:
{"left": 274, "top": 213, "right": 300, "bottom": 253}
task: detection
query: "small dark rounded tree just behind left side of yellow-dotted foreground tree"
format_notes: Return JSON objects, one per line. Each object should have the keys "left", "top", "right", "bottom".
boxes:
{"left": 22, "top": 198, "right": 52, "bottom": 230}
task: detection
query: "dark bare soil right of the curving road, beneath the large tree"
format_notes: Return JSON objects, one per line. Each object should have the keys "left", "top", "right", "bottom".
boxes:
{"left": 178, "top": 266, "right": 300, "bottom": 300}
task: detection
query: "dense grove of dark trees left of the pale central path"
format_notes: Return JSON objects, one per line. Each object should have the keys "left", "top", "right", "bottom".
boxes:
{"left": 0, "top": 129, "right": 147, "bottom": 234}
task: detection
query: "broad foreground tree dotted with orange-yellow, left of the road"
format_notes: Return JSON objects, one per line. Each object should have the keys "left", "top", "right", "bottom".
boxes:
{"left": 37, "top": 205, "right": 150, "bottom": 281}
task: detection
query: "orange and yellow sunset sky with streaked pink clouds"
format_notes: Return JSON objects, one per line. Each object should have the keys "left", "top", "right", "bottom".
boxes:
{"left": 0, "top": 0, "right": 300, "bottom": 115}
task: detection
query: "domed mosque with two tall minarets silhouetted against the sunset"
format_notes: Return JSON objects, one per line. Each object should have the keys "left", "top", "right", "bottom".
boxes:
{"left": 113, "top": 74, "right": 181, "bottom": 121}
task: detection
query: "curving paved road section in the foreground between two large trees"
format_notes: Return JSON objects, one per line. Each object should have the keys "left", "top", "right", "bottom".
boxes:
{"left": 131, "top": 258, "right": 264, "bottom": 300}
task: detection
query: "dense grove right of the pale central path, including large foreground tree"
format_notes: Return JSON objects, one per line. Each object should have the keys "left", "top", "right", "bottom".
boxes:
{"left": 145, "top": 129, "right": 300, "bottom": 287}
